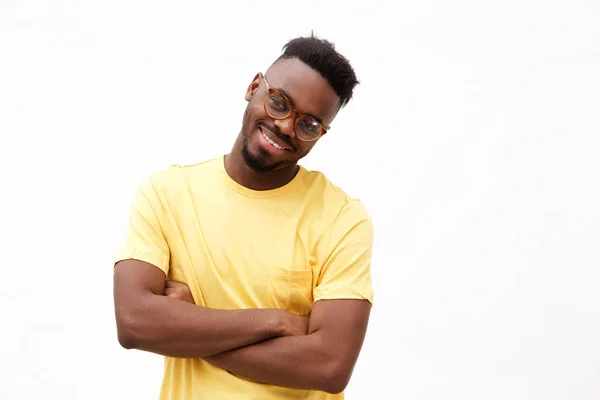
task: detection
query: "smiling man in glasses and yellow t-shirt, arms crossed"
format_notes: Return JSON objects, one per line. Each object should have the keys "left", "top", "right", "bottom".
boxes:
{"left": 114, "top": 37, "right": 373, "bottom": 400}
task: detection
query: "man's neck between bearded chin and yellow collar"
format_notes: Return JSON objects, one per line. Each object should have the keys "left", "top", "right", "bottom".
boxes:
{"left": 225, "top": 140, "right": 299, "bottom": 190}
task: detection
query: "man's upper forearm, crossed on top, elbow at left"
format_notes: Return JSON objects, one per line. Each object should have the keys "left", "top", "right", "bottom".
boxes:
{"left": 117, "top": 294, "right": 281, "bottom": 358}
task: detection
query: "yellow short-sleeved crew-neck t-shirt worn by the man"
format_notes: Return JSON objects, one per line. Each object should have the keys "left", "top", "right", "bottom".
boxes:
{"left": 117, "top": 156, "right": 373, "bottom": 400}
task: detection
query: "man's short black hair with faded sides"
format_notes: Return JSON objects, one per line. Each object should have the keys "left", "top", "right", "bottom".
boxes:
{"left": 277, "top": 34, "right": 359, "bottom": 108}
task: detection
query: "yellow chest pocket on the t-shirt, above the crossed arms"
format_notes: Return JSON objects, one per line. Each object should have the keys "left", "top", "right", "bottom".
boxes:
{"left": 271, "top": 267, "right": 313, "bottom": 315}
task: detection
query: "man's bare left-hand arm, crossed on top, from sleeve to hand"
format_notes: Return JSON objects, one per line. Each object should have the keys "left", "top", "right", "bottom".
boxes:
{"left": 114, "top": 260, "right": 308, "bottom": 358}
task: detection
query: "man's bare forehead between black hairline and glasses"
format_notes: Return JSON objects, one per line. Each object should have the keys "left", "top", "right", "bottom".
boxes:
{"left": 266, "top": 58, "right": 340, "bottom": 125}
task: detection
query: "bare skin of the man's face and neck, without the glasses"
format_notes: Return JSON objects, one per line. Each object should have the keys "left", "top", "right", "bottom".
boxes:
{"left": 225, "top": 59, "right": 340, "bottom": 190}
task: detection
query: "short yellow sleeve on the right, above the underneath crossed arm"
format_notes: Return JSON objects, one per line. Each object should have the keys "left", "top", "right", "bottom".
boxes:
{"left": 313, "top": 200, "right": 374, "bottom": 303}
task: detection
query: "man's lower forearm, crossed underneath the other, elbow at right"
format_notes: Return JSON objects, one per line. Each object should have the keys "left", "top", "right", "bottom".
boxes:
{"left": 205, "top": 332, "right": 345, "bottom": 392}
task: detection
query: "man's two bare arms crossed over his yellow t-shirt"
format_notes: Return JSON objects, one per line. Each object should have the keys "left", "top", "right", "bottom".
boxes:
{"left": 114, "top": 260, "right": 371, "bottom": 393}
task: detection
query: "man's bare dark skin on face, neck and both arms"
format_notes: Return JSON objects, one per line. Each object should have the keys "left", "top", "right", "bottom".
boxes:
{"left": 114, "top": 59, "right": 371, "bottom": 393}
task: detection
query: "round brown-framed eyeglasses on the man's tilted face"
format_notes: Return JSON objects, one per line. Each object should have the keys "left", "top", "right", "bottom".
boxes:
{"left": 263, "top": 76, "right": 329, "bottom": 142}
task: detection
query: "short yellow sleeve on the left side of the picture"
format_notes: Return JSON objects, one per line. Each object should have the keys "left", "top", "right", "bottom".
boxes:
{"left": 115, "top": 175, "right": 169, "bottom": 275}
